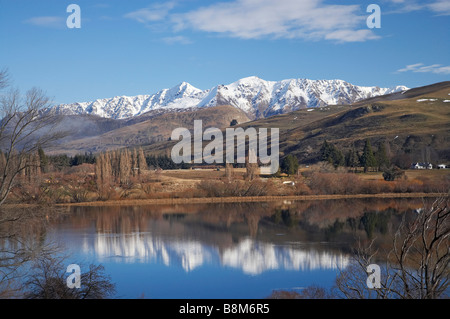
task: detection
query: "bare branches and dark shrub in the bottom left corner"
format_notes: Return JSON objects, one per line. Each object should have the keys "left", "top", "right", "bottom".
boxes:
{"left": 0, "top": 207, "right": 115, "bottom": 299}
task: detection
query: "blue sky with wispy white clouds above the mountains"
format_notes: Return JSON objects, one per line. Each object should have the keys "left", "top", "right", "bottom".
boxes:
{"left": 0, "top": 0, "right": 450, "bottom": 103}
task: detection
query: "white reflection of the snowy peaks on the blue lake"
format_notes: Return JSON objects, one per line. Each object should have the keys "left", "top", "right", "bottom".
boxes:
{"left": 83, "top": 233, "right": 349, "bottom": 275}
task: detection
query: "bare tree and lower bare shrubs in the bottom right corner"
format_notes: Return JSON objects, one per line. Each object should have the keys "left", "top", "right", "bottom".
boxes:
{"left": 336, "top": 195, "right": 450, "bottom": 299}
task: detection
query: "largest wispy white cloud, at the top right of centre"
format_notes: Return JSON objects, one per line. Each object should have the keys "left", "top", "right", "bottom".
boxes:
{"left": 171, "top": 0, "right": 376, "bottom": 42}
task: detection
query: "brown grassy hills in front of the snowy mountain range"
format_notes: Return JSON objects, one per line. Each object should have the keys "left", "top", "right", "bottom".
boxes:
{"left": 45, "top": 81, "right": 450, "bottom": 164}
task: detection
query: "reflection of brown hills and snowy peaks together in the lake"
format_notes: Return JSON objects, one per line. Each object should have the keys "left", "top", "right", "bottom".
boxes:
{"left": 56, "top": 200, "right": 423, "bottom": 275}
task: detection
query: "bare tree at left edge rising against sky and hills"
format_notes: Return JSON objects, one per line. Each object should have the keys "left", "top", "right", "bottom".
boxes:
{"left": 0, "top": 70, "right": 65, "bottom": 206}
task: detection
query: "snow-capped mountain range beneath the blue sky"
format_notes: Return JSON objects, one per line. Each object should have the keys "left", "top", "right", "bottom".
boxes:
{"left": 51, "top": 76, "right": 408, "bottom": 119}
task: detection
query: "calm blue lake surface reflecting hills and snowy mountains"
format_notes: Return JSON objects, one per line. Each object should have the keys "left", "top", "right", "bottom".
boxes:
{"left": 44, "top": 200, "right": 422, "bottom": 299}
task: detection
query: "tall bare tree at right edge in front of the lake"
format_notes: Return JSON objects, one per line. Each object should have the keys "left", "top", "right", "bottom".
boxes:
{"left": 392, "top": 196, "right": 450, "bottom": 299}
